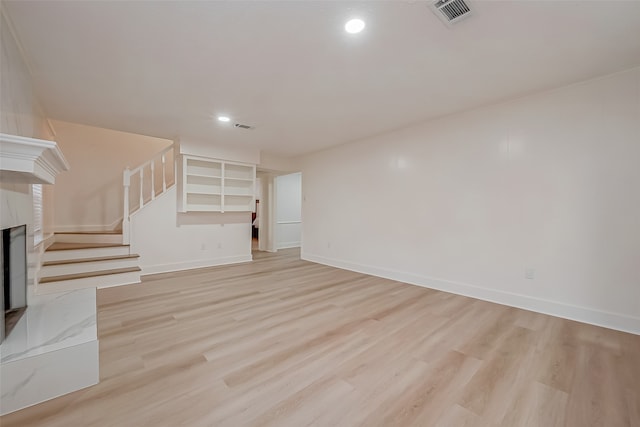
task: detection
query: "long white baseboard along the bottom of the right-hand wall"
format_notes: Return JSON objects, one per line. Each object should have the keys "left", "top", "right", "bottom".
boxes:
{"left": 301, "top": 252, "right": 640, "bottom": 335}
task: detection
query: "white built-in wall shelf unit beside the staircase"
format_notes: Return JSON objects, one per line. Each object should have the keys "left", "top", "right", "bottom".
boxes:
{"left": 178, "top": 154, "right": 256, "bottom": 212}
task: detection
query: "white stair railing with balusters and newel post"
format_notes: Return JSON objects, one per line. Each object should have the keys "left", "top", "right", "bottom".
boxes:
{"left": 122, "top": 145, "right": 176, "bottom": 245}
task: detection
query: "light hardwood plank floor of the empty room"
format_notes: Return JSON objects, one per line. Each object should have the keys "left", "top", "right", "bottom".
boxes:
{"left": 0, "top": 250, "right": 640, "bottom": 427}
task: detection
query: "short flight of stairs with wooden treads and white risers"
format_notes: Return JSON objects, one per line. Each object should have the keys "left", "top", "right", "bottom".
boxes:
{"left": 37, "top": 232, "right": 141, "bottom": 294}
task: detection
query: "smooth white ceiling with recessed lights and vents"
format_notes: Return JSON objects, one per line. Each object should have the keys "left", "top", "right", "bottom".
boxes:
{"left": 3, "top": 0, "right": 640, "bottom": 156}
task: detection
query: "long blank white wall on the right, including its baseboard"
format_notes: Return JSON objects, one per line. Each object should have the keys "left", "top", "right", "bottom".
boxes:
{"left": 301, "top": 68, "right": 640, "bottom": 333}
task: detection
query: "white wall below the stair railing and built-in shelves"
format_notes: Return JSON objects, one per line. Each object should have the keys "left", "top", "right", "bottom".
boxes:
{"left": 131, "top": 186, "right": 252, "bottom": 274}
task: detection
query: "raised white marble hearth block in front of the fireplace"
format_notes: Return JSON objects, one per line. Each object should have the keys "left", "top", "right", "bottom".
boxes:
{"left": 0, "top": 288, "right": 99, "bottom": 415}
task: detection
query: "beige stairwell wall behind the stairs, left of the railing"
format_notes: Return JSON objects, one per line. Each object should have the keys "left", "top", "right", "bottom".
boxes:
{"left": 53, "top": 121, "right": 173, "bottom": 231}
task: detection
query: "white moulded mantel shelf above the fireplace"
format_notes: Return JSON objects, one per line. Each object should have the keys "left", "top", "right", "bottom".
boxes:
{"left": 0, "top": 133, "right": 69, "bottom": 184}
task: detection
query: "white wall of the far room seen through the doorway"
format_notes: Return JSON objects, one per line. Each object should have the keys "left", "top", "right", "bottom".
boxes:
{"left": 275, "top": 173, "right": 302, "bottom": 249}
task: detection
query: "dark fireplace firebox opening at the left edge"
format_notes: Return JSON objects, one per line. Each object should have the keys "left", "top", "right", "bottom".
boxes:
{"left": 0, "top": 225, "right": 27, "bottom": 342}
